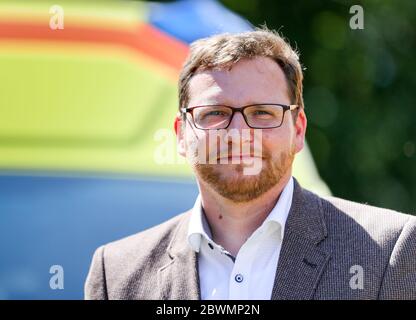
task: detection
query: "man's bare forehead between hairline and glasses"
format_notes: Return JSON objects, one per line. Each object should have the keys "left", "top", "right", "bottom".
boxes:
{"left": 189, "top": 57, "right": 290, "bottom": 106}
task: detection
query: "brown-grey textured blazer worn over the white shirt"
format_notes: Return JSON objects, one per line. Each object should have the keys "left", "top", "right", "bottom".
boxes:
{"left": 85, "top": 180, "right": 416, "bottom": 300}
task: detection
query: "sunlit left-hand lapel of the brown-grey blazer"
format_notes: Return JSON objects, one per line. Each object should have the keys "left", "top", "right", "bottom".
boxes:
{"left": 158, "top": 211, "right": 200, "bottom": 300}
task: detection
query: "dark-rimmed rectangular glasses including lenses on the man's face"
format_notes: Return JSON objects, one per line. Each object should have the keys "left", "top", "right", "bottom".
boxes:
{"left": 180, "top": 103, "right": 299, "bottom": 130}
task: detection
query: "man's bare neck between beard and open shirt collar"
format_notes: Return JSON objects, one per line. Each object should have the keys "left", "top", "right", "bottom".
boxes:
{"left": 199, "top": 172, "right": 291, "bottom": 257}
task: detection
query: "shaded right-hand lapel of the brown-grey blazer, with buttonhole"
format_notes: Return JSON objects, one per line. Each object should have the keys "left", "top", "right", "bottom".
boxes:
{"left": 271, "top": 179, "right": 330, "bottom": 300}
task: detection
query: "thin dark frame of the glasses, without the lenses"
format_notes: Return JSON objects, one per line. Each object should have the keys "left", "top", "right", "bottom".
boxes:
{"left": 180, "top": 103, "right": 299, "bottom": 130}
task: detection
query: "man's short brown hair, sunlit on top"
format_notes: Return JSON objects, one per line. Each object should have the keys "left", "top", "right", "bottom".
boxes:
{"left": 179, "top": 28, "right": 304, "bottom": 114}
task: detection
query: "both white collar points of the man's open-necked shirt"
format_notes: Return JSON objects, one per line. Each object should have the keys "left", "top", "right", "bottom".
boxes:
{"left": 187, "top": 177, "right": 294, "bottom": 252}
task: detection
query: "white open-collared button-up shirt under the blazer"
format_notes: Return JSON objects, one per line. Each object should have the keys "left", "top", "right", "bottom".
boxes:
{"left": 187, "top": 177, "right": 293, "bottom": 300}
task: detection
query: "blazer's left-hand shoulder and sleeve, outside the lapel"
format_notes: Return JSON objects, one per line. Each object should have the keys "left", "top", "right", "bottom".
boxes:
{"left": 85, "top": 211, "right": 189, "bottom": 299}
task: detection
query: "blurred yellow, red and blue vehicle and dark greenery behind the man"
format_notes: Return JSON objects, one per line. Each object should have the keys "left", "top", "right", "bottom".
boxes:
{"left": 0, "top": 0, "right": 416, "bottom": 299}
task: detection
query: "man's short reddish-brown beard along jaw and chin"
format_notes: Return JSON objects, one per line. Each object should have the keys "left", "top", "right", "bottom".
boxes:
{"left": 194, "top": 145, "right": 296, "bottom": 203}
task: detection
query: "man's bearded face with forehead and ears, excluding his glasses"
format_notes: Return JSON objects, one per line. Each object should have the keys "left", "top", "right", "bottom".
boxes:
{"left": 178, "top": 57, "right": 306, "bottom": 203}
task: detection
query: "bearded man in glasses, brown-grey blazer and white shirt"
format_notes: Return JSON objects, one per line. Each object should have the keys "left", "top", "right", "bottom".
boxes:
{"left": 85, "top": 30, "right": 416, "bottom": 299}
